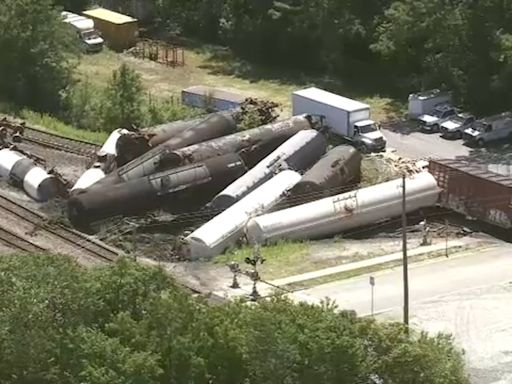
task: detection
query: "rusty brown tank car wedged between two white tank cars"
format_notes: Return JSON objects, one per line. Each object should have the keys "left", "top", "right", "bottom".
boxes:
{"left": 288, "top": 145, "right": 361, "bottom": 204}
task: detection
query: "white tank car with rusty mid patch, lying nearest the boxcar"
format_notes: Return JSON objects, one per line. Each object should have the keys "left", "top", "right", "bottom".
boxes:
{"left": 246, "top": 172, "right": 440, "bottom": 243}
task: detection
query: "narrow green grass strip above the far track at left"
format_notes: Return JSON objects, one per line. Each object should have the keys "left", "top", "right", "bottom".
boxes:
{"left": 0, "top": 104, "right": 109, "bottom": 144}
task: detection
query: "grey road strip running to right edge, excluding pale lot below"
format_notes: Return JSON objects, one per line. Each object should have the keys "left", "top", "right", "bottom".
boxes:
{"left": 297, "top": 246, "right": 512, "bottom": 315}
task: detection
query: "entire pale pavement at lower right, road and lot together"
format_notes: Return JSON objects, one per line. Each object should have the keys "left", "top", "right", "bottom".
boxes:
{"left": 290, "top": 246, "right": 512, "bottom": 384}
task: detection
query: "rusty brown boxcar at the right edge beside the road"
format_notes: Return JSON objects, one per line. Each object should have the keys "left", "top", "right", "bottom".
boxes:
{"left": 429, "top": 160, "right": 512, "bottom": 229}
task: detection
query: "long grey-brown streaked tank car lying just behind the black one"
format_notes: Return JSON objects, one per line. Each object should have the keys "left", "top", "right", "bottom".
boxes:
{"left": 94, "top": 116, "right": 311, "bottom": 185}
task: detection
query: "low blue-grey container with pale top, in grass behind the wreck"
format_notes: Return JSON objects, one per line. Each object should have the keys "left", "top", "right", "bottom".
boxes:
{"left": 181, "top": 85, "right": 246, "bottom": 111}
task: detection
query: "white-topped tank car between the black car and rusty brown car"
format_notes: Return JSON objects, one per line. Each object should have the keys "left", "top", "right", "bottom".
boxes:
{"left": 211, "top": 129, "right": 327, "bottom": 209}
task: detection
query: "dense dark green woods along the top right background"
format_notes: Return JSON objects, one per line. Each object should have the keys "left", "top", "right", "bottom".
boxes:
{"left": 147, "top": 0, "right": 512, "bottom": 113}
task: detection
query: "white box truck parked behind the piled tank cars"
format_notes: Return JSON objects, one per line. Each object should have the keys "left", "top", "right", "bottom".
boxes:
{"left": 292, "top": 87, "right": 386, "bottom": 153}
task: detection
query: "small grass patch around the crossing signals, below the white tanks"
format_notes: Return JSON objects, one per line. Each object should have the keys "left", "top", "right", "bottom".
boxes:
{"left": 213, "top": 241, "right": 309, "bottom": 280}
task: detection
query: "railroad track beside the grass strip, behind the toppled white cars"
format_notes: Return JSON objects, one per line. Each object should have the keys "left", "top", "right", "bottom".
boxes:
{"left": 23, "top": 127, "right": 100, "bottom": 157}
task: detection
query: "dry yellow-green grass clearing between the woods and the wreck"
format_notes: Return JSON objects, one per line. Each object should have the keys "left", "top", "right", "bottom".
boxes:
{"left": 78, "top": 47, "right": 402, "bottom": 121}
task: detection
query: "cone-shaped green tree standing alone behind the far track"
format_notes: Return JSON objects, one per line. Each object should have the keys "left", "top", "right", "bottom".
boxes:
{"left": 103, "top": 63, "right": 144, "bottom": 130}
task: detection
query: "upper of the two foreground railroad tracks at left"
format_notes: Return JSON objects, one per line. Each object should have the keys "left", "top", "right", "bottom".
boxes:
{"left": 0, "top": 194, "right": 119, "bottom": 262}
